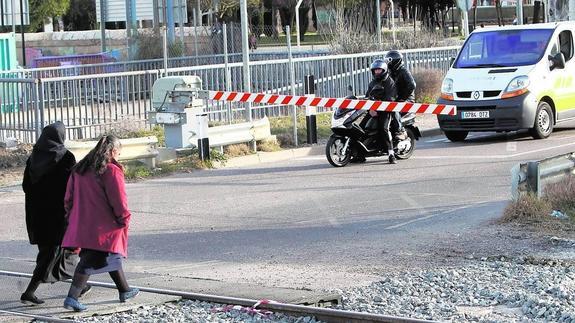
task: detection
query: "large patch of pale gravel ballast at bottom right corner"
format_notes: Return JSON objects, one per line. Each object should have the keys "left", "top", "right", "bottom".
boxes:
{"left": 341, "top": 258, "right": 575, "bottom": 323}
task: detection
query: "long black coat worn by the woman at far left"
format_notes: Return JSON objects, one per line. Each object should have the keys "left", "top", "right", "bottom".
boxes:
{"left": 22, "top": 151, "right": 76, "bottom": 245}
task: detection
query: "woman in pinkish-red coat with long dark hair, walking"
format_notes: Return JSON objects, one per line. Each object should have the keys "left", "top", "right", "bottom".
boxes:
{"left": 62, "top": 135, "right": 139, "bottom": 312}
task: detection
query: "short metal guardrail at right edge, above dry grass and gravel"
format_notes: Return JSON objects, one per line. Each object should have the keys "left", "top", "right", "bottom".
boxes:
{"left": 511, "top": 153, "right": 575, "bottom": 200}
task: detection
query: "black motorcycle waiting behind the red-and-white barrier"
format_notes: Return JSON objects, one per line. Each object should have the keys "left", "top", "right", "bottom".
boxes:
{"left": 325, "top": 91, "right": 421, "bottom": 167}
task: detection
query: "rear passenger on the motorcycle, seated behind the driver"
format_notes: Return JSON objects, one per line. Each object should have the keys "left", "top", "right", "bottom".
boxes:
{"left": 385, "top": 50, "right": 417, "bottom": 140}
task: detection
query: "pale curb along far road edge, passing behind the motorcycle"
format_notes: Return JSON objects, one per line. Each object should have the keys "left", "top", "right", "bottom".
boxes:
{"left": 214, "top": 128, "right": 443, "bottom": 168}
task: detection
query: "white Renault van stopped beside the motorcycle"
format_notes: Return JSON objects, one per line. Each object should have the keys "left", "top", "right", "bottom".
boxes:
{"left": 437, "top": 22, "right": 575, "bottom": 141}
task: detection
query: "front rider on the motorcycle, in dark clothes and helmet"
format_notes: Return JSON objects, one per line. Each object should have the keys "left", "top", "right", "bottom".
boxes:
{"left": 365, "top": 59, "right": 397, "bottom": 164}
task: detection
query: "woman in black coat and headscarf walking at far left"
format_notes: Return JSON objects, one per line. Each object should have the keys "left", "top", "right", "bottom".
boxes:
{"left": 20, "top": 122, "right": 76, "bottom": 305}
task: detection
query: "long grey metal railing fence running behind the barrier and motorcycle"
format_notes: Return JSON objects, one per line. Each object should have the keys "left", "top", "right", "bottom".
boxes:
{"left": 0, "top": 47, "right": 458, "bottom": 143}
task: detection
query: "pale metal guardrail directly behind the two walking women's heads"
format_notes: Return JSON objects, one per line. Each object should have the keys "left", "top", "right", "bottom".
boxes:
{"left": 66, "top": 136, "right": 158, "bottom": 168}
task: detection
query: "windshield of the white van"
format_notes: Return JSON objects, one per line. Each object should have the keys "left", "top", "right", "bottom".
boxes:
{"left": 454, "top": 29, "right": 553, "bottom": 68}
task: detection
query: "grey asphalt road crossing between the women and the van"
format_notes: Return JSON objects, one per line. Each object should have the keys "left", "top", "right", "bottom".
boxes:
{"left": 0, "top": 129, "right": 575, "bottom": 318}
